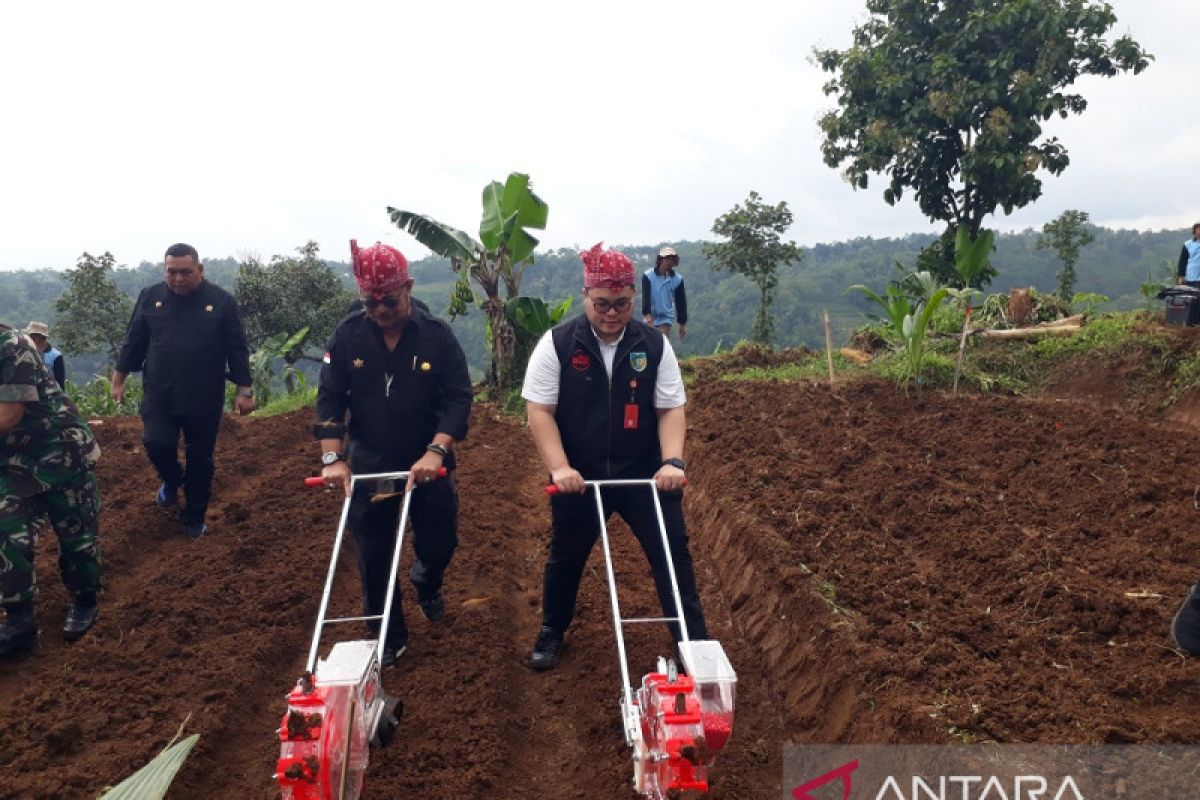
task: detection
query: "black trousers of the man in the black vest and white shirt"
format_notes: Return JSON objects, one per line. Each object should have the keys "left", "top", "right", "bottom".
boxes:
{"left": 541, "top": 486, "right": 708, "bottom": 642}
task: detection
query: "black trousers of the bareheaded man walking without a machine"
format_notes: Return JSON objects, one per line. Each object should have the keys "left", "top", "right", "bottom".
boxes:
{"left": 142, "top": 403, "right": 221, "bottom": 522}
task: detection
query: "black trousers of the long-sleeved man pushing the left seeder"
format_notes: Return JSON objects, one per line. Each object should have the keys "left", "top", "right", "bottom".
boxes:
{"left": 349, "top": 476, "right": 458, "bottom": 646}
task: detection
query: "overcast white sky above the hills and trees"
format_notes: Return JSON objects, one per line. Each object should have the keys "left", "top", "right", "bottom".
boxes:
{"left": 0, "top": 0, "right": 1200, "bottom": 269}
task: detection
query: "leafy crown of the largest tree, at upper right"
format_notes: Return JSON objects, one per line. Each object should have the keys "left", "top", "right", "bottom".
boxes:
{"left": 814, "top": 0, "right": 1153, "bottom": 237}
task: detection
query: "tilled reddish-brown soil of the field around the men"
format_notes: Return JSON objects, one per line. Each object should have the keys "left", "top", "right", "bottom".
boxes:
{"left": 0, "top": 381, "right": 1200, "bottom": 800}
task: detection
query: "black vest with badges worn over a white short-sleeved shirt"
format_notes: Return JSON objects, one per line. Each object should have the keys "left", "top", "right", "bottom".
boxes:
{"left": 551, "top": 314, "right": 662, "bottom": 480}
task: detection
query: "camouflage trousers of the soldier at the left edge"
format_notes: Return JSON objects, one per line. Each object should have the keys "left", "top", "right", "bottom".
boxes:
{"left": 0, "top": 469, "right": 101, "bottom": 606}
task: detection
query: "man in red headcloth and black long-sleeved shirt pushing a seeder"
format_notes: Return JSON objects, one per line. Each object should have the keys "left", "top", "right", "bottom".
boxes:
{"left": 313, "top": 241, "right": 472, "bottom": 667}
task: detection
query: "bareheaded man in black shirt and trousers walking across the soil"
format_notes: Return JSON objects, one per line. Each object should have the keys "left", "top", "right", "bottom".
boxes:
{"left": 112, "top": 245, "right": 254, "bottom": 539}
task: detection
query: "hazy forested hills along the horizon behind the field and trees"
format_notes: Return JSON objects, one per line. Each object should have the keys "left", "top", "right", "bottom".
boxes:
{"left": 0, "top": 228, "right": 1189, "bottom": 380}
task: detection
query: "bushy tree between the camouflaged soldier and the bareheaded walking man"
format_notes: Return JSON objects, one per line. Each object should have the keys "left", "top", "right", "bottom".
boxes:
{"left": 54, "top": 251, "right": 133, "bottom": 371}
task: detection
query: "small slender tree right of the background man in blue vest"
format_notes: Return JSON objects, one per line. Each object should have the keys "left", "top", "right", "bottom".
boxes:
{"left": 704, "top": 192, "right": 804, "bottom": 347}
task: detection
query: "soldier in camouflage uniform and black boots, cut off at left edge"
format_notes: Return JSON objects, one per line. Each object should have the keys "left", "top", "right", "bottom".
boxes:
{"left": 0, "top": 324, "right": 100, "bottom": 658}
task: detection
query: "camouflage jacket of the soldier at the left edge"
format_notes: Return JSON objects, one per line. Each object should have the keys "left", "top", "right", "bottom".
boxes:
{"left": 0, "top": 324, "right": 100, "bottom": 497}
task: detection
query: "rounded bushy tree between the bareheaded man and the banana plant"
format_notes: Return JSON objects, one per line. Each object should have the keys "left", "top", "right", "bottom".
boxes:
{"left": 234, "top": 241, "right": 354, "bottom": 393}
